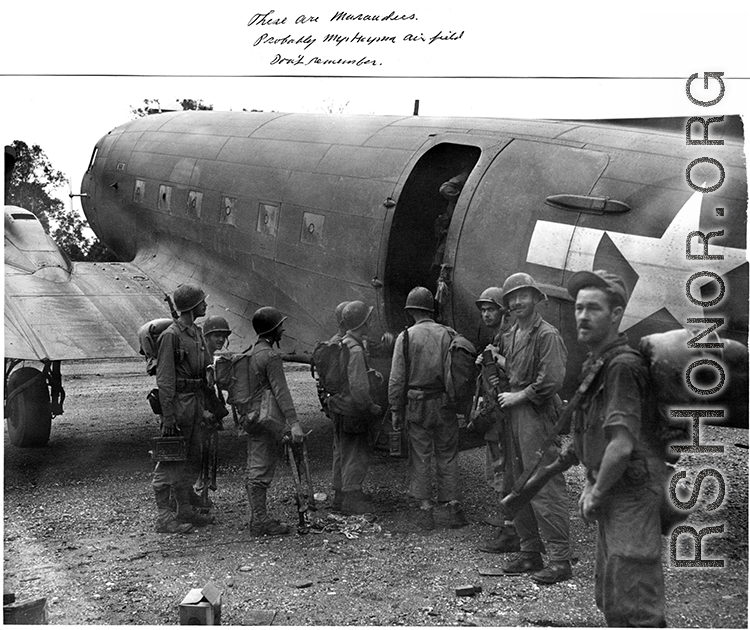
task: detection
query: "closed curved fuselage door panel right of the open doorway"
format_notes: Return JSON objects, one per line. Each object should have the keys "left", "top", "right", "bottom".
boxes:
{"left": 446, "top": 139, "right": 608, "bottom": 336}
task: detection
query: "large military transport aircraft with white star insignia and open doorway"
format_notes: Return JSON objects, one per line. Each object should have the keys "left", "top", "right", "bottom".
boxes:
{"left": 5, "top": 112, "right": 748, "bottom": 446}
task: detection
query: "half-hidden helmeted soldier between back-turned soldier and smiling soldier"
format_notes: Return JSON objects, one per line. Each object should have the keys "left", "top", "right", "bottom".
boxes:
{"left": 475, "top": 287, "right": 520, "bottom": 553}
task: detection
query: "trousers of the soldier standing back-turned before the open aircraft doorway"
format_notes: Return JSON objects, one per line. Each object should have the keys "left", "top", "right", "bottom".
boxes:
{"left": 405, "top": 390, "right": 461, "bottom": 503}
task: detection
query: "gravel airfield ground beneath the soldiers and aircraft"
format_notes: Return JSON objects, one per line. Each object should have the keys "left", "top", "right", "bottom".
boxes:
{"left": 3, "top": 361, "right": 748, "bottom": 628}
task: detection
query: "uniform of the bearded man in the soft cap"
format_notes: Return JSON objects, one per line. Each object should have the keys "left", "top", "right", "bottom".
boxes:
{"left": 572, "top": 334, "right": 666, "bottom": 627}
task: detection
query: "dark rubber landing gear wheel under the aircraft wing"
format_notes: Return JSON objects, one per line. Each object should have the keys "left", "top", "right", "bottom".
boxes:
{"left": 5, "top": 367, "right": 52, "bottom": 447}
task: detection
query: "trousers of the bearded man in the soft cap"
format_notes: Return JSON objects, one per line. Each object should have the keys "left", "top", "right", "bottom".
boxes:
{"left": 594, "top": 484, "right": 666, "bottom": 628}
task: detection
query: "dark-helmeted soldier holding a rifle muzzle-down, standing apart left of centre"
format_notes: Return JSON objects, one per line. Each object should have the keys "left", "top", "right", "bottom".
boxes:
{"left": 243, "top": 306, "right": 305, "bottom": 536}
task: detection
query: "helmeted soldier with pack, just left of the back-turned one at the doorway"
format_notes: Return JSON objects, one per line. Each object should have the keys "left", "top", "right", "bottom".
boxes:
{"left": 328, "top": 300, "right": 383, "bottom": 514}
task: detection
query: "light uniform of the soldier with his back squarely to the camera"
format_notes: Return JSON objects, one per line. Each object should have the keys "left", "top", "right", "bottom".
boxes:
{"left": 388, "top": 319, "right": 461, "bottom": 502}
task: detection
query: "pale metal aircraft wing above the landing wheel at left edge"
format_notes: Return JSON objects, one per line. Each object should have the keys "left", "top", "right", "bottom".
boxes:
{"left": 5, "top": 263, "right": 169, "bottom": 360}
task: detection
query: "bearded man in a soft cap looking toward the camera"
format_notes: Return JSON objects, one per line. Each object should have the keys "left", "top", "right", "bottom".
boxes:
{"left": 568, "top": 271, "right": 666, "bottom": 627}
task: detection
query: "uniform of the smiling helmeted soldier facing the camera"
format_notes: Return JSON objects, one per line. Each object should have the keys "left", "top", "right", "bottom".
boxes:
{"left": 498, "top": 313, "right": 570, "bottom": 562}
